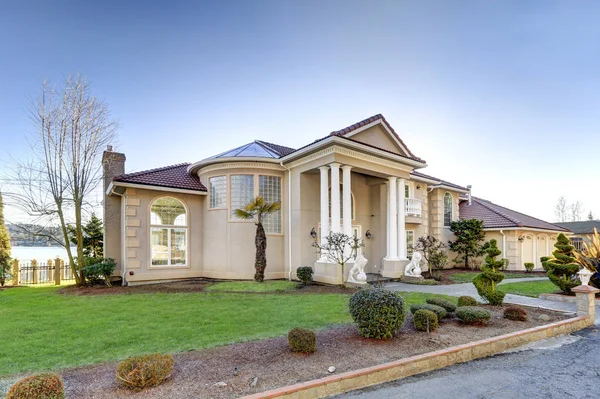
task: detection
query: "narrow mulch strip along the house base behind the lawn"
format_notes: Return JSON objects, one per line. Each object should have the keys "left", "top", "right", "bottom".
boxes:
{"left": 58, "top": 279, "right": 358, "bottom": 295}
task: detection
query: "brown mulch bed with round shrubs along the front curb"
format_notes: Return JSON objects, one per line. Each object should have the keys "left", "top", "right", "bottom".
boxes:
{"left": 39, "top": 306, "right": 569, "bottom": 399}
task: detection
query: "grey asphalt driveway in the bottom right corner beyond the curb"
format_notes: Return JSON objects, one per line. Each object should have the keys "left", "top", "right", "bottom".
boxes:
{"left": 336, "top": 327, "right": 600, "bottom": 399}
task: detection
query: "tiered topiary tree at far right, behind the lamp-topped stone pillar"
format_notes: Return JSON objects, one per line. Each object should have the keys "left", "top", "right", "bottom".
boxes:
{"left": 542, "top": 233, "right": 581, "bottom": 294}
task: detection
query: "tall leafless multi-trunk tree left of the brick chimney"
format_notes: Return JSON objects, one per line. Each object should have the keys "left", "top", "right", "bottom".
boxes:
{"left": 7, "top": 75, "right": 118, "bottom": 285}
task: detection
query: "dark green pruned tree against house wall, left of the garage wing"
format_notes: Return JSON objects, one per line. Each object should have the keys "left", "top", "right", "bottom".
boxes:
{"left": 448, "top": 219, "right": 485, "bottom": 269}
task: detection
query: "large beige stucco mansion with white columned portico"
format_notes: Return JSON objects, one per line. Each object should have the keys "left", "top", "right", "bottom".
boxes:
{"left": 103, "top": 115, "right": 562, "bottom": 284}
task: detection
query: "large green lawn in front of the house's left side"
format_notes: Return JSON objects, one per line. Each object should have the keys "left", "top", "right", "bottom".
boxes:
{"left": 0, "top": 283, "right": 456, "bottom": 375}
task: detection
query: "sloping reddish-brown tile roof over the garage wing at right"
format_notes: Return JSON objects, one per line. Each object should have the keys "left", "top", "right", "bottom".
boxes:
{"left": 459, "top": 197, "right": 569, "bottom": 232}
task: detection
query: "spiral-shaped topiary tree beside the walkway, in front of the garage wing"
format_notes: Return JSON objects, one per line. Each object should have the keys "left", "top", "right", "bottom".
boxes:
{"left": 473, "top": 240, "right": 506, "bottom": 306}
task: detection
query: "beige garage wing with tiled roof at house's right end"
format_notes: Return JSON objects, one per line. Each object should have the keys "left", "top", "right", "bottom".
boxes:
{"left": 460, "top": 195, "right": 570, "bottom": 270}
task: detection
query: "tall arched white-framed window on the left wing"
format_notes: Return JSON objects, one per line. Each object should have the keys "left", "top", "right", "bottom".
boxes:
{"left": 150, "top": 197, "right": 188, "bottom": 266}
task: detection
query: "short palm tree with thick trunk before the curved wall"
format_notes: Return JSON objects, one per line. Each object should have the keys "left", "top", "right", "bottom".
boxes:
{"left": 235, "top": 195, "right": 281, "bottom": 283}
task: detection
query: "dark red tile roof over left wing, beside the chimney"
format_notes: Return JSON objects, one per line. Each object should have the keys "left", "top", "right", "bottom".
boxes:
{"left": 113, "top": 163, "right": 206, "bottom": 191}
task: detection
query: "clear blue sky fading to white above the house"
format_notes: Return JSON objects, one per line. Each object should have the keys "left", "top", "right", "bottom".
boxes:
{"left": 0, "top": 0, "right": 600, "bottom": 220}
